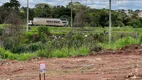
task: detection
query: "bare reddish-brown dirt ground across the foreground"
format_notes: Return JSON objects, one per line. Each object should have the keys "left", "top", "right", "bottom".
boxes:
{"left": 0, "top": 45, "right": 142, "bottom": 80}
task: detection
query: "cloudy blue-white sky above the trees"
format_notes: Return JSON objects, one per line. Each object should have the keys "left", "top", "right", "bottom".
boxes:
{"left": 0, "top": 0, "right": 142, "bottom": 10}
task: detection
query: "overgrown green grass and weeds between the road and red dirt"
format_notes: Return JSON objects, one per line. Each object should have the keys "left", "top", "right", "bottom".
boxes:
{"left": 1, "top": 26, "right": 142, "bottom": 60}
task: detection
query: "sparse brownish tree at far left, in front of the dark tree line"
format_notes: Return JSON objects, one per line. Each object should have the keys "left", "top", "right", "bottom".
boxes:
{"left": 2, "top": 11, "right": 24, "bottom": 53}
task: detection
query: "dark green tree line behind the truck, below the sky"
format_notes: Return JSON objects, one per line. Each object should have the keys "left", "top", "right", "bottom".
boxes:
{"left": 0, "top": 0, "right": 142, "bottom": 28}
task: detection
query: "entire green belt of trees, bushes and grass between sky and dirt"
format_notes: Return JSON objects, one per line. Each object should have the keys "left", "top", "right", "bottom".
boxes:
{"left": 0, "top": 0, "right": 142, "bottom": 60}
